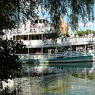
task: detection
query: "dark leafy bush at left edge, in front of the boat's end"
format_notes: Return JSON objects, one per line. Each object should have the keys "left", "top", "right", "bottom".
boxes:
{"left": 0, "top": 40, "right": 23, "bottom": 85}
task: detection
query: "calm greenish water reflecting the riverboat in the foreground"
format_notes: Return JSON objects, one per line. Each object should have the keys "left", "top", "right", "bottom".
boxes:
{"left": 0, "top": 67, "right": 95, "bottom": 95}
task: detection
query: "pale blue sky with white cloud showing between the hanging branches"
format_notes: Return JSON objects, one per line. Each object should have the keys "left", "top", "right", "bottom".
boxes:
{"left": 38, "top": 5, "right": 95, "bottom": 34}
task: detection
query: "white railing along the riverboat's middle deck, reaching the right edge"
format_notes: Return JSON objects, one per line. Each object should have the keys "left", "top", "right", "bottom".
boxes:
{"left": 23, "top": 38, "right": 95, "bottom": 47}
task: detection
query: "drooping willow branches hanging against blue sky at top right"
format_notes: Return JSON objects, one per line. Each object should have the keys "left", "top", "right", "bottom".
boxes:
{"left": 38, "top": 0, "right": 94, "bottom": 29}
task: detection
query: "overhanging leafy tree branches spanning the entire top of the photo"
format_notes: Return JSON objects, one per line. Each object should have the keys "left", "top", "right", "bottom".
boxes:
{"left": 0, "top": 0, "right": 94, "bottom": 30}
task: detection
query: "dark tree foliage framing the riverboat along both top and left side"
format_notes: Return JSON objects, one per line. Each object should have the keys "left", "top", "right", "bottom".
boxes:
{"left": 0, "top": 0, "right": 94, "bottom": 88}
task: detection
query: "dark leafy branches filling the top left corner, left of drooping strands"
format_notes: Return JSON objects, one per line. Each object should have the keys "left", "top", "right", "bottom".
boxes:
{"left": 0, "top": 0, "right": 36, "bottom": 30}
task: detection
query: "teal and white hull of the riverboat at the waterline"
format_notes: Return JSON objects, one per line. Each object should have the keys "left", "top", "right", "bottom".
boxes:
{"left": 17, "top": 55, "right": 95, "bottom": 67}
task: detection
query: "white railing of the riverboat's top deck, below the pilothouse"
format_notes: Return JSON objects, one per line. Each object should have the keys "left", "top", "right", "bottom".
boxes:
{"left": 12, "top": 24, "right": 55, "bottom": 35}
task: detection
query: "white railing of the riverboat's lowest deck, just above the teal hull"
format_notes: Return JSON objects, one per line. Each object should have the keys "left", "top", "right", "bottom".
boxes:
{"left": 17, "top": 51, "right": 85, "bottom": 59}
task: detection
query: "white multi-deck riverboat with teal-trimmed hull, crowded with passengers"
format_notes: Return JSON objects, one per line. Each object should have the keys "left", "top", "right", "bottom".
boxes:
{"left": 7, "top": 18, "right": 95, "bottom": 71}
